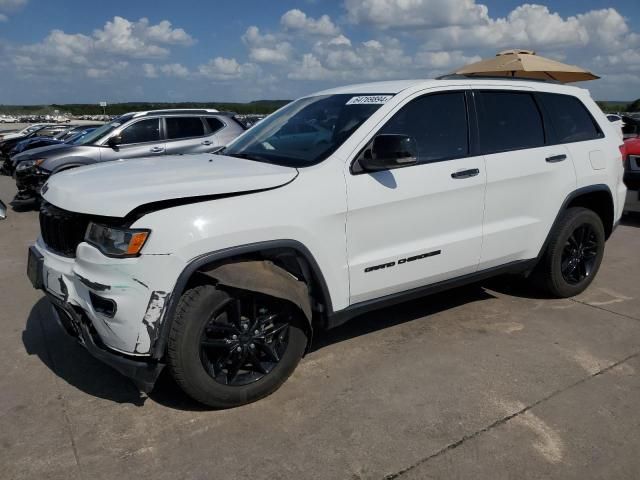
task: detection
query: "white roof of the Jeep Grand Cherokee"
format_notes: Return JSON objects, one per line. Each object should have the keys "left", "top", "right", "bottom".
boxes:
{"left": 314, "top": 75, "right": 585, "bottom": 95}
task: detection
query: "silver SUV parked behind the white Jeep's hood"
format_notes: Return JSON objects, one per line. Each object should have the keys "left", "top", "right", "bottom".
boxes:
{"left": 12, "top": 109, "right": 245, "bottom": 207}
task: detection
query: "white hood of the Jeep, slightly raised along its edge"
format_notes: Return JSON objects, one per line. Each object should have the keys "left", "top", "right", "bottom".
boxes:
{"left": 42, "top": 153, "right": 298, "bottom": 217}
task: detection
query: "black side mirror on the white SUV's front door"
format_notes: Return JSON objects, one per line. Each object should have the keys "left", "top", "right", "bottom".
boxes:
{"left": 358, "top": 134, "right": 418, "bottom": 172}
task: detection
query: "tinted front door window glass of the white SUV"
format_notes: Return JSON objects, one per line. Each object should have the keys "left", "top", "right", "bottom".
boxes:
{"left": 378, "top": 92, "right": 469, "bottom": 162}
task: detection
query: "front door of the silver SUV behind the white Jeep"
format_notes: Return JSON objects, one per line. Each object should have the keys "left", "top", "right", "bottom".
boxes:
{"left": 100, "top": 118, "right": 165, "bottom": 161}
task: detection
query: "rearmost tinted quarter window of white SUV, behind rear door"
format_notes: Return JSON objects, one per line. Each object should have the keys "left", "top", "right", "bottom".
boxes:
{"left": 538, "top": 93, "right": 602, "bottom": 143}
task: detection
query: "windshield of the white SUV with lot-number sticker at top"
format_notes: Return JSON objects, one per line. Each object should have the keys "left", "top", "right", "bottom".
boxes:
{"left": 219, "top": 94, "right": 392, "bottom": 168}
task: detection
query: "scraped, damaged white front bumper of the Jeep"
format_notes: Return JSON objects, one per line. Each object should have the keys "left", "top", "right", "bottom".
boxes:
{"left": 28, "top": 238, "right": 184, "bottom": 391}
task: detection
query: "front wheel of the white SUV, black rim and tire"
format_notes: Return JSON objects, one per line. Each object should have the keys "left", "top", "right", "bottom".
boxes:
{"left": 167, "top": 285, "right": 307, "bottom": 408}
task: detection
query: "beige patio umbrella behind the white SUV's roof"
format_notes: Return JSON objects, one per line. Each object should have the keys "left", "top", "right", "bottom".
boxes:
{"left": 455, "top": 50, "right": 600, "bottom": 83}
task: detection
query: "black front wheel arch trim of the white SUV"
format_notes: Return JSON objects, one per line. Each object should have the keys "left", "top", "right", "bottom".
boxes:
{"left": 152, "top": 239, "right": 333, "bottom": 360}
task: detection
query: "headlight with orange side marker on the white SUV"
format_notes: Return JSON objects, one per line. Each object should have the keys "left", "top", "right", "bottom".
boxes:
{"left": 84, "top": 223, "right": 151, "bottom": 257}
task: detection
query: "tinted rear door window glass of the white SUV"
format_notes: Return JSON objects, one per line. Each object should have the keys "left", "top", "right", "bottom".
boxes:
{"left": 476, "top": 92, "right": 544, "bottom": 153}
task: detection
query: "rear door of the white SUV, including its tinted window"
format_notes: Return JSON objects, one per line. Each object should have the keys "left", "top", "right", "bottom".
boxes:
{"left": 474, "top": 89, "right": 576, "bottom": 269}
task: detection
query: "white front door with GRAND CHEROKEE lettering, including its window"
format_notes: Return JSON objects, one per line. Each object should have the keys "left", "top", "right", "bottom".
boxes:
{"left": 346, "top": 91, "right": 486, "bottom": 304}
